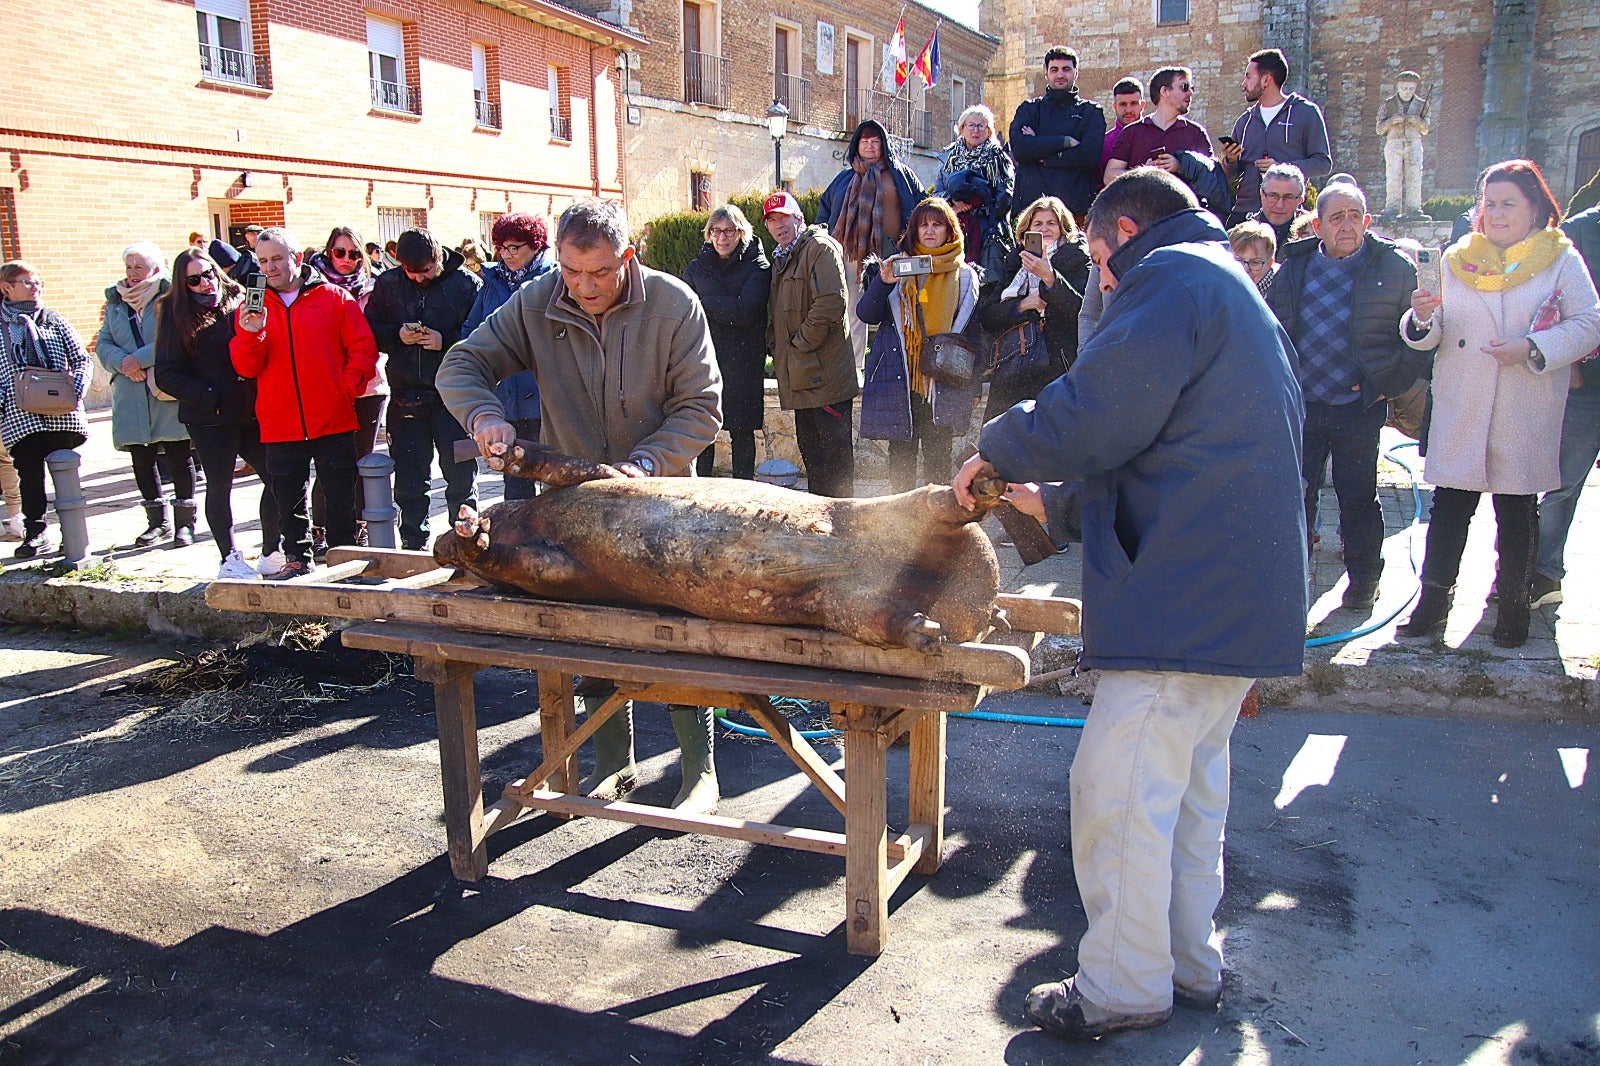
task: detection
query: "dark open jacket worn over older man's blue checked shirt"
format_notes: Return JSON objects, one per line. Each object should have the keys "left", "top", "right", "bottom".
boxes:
{"left": 1267, "top": 234, "right": 1429, "bottom": 405}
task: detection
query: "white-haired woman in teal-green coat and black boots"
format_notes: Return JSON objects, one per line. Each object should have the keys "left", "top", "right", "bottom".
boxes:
{"left": 94, "top": 240, "right": 197, "bottom": 547}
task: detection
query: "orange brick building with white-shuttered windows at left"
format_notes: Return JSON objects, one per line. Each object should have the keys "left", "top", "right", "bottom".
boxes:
{"left": 0, "top": 0, "right": 645, "bottom": 390}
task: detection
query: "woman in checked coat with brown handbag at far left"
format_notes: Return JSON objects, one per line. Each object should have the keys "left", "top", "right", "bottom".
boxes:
{"left": 0, "top": 259, "right": 90, "bottom": 559}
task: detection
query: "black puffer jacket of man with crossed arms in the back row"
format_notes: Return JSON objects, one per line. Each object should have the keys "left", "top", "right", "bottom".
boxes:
{"left": 1011, "top": 90, "right": 1106, "bottom": 218}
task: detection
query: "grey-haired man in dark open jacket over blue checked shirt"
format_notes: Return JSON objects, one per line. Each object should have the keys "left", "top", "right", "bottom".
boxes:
{"left": 1267, "top": 182, "right": 1421, "bottom": 611}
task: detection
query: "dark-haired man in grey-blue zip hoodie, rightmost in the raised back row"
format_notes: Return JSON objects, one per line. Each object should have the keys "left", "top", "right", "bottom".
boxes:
{"left": 1222, "top": 48, "right": 1333, "bottom": 226}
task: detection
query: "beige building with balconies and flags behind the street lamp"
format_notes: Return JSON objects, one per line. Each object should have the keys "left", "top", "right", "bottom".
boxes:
{"left": 560, "top": 0, "right": 997, "bottom": 224}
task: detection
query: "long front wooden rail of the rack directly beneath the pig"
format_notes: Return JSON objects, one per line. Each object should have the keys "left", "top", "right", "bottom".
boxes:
{"left": 206, "top": 560, "right": 1029, "bottom": 690}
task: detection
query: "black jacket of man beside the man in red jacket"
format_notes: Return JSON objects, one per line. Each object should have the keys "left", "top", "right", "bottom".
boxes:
{"left": 366, "top": 248, "right": 482, "bottom": 396}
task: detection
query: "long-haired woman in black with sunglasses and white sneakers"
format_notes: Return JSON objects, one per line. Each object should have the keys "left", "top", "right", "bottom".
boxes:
{"left": 155, "top": 248, "right": 278, "bottom": 579}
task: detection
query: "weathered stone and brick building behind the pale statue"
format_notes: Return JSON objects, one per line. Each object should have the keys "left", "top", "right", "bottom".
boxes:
{"left": 982, "top": 0, "right": 1600, "bottom": 198}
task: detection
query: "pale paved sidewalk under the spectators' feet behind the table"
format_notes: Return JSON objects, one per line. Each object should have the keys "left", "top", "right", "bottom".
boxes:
{"left": 0, "top": 411, "right": 1600, "bottom": 719}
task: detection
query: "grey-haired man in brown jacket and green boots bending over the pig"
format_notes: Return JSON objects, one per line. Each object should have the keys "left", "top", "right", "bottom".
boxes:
{"left": 435, "top": 200, "right": 722, "bottom": 813}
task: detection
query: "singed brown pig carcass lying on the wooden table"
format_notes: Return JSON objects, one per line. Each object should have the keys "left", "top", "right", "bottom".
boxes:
{"left": 434, "top": 442, "right": 1005, "bottom": 650}
